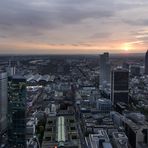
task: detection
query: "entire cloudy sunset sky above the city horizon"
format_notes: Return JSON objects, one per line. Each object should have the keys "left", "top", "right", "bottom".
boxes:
{"left": 0, "top": 0, "right": 148, "bottom": 54}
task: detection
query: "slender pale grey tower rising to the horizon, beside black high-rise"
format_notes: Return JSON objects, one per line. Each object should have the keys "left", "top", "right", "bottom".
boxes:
{"left": 100, "top": 52, "right": 110, "bottom": 86}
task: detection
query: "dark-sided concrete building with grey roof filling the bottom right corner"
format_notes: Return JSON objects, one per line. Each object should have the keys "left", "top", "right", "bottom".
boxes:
{"left": 111, "top": 112, "right": 148, "bottom": 148}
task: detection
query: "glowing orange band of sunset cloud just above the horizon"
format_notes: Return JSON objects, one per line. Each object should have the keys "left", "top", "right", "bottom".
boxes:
{"left": 0, "top": 41, "right": 145, "bottom": 54}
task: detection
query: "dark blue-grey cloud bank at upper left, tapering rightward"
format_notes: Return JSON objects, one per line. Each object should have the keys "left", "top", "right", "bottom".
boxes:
{"left": 0, "top": 0, "right": 113, "bottom": 31}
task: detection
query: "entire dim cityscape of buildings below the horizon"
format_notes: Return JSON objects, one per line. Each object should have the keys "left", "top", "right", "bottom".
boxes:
{"left": 0, "top": 52, "right": 148, "bottom": 148}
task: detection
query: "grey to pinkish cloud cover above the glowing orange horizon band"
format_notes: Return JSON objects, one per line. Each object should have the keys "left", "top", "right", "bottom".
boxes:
{"left": 0, "top": 0, "right": 148, "bottom": 53}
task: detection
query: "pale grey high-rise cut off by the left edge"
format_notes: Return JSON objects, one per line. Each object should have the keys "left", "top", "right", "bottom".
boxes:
{"left": 0, "top": 72, "right": 8, "bottom": 134}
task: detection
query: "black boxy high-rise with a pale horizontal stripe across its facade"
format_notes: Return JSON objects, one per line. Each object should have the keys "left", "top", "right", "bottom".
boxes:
{"left": 111, "top": 68, "right": 129, "bottom": 106}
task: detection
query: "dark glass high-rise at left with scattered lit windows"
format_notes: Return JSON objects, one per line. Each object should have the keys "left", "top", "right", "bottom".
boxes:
{"left": 8, "top": 76, "right": 26, "bottom": 148}
